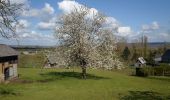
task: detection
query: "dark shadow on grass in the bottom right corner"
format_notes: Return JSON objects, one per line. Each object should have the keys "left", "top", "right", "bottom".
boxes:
{"left": 120, "top": 91, "right": 170, "bottom": 100}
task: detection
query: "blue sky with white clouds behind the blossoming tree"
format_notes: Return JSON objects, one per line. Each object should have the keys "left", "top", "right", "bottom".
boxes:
{"left": 0, "top": 0, "right": 170, "bottom": 45}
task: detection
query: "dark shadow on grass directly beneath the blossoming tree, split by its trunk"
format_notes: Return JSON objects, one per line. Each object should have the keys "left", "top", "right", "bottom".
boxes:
{"left": 40, "top": 72, "right": 109, "bottom": 80}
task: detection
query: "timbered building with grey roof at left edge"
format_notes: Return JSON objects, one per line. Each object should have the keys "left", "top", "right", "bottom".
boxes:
{"left": 0, "top": 44, "right": 18, "bottom": 82}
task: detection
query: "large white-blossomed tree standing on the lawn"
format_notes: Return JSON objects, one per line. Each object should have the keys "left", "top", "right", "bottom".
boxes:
{"left": 56, "top": 6, "right": 122, "bottom": 79}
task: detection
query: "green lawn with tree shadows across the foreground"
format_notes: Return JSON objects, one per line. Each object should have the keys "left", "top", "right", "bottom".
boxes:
{"left": 0, "top": 68, "right": 170, "bottom": 100}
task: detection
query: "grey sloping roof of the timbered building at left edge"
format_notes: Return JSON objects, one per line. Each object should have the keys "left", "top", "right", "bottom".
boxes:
{"left": 0, "top": 44, "right": 18, "bottom": 57}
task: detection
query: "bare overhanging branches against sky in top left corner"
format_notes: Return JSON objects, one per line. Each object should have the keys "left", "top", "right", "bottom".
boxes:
{"left": 0, "top": 0, "right": 23, "bottom": 38}
